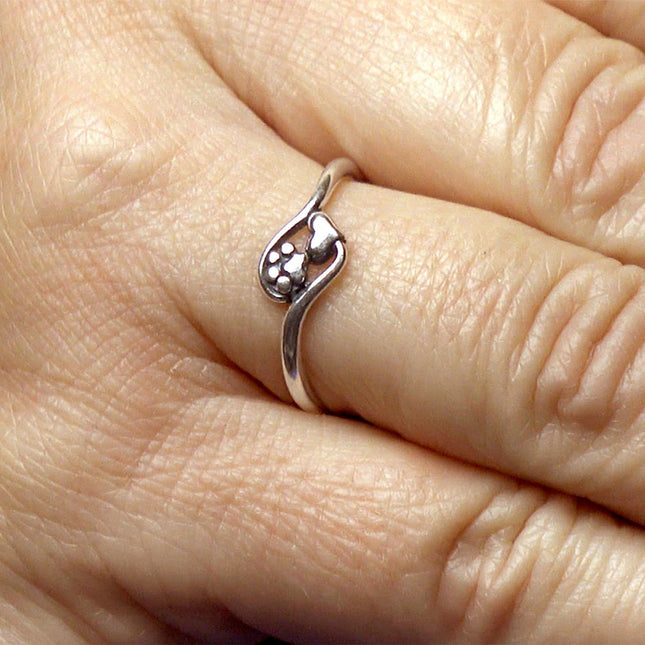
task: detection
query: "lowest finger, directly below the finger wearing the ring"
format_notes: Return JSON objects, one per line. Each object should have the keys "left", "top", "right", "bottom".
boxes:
{"left": 124, "top": 400, "right": 644, "bottom": 643}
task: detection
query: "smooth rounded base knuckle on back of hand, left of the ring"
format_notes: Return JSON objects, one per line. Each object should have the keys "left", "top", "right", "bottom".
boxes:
{"left": 11, "top": 79, "right": 166, "bottom": 231}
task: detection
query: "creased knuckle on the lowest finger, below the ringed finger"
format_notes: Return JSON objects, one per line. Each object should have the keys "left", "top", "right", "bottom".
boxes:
{"left": 437, "top": 487, "right": 577, "bottom": 643}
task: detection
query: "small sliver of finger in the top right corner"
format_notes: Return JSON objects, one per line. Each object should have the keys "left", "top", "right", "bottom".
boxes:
{"left": 547, "top": 0, "right": 645, "bottom": 49}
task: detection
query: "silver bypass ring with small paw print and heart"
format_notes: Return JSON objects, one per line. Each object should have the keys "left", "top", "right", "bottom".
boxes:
{"left": 258, "top": 159, "right": 360, "bottom": 412}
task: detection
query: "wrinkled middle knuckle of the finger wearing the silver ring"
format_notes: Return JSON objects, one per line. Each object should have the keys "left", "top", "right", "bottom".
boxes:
{"left": 526, "top": 261, "right": 645, "bottom": 429}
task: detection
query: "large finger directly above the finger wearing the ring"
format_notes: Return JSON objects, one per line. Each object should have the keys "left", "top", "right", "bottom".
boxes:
{"left": 176, "top": 0, "right": 645, "bottom": 264}
